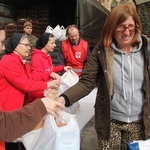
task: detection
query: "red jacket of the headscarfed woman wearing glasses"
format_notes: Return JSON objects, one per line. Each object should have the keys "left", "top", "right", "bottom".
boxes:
{"left": 0, "top": 53, "right": 47, "bottom": 111}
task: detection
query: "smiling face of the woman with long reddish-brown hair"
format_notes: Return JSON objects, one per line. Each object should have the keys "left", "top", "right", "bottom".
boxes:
{"left": 114, "top": 16, "right": 135, "bottom": 49}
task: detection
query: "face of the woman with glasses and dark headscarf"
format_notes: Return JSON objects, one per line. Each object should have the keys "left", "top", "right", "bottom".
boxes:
{"left": 13, "top": 38, "right": 30, "bottom": 59}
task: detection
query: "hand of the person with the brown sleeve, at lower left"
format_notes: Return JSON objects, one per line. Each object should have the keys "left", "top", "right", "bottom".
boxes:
{"left": 41, "top": 97, "right": 65, "bottom": 118}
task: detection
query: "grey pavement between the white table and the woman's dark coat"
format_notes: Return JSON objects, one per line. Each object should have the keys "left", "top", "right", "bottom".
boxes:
{"left": 80, "top": 117, "right": 98, "bottom": 150}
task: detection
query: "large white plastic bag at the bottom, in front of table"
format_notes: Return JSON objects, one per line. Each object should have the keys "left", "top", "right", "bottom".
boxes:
{"left": 21, "top": 112, "right": 80, "bottom": 150}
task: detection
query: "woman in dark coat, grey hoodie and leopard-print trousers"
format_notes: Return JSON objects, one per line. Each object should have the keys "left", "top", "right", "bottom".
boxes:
{"left": 58, "top": 4, "right": 150, "bottom": 150}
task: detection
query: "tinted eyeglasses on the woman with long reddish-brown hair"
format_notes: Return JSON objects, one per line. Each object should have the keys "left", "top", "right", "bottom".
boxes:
{"left": 116, "top": 24, "right": 135, "bottom": 33}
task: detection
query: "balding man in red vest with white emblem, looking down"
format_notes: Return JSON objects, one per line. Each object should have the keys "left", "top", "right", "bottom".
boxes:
{"left": 58, "top": 24, "right": 90, "bottom": 76}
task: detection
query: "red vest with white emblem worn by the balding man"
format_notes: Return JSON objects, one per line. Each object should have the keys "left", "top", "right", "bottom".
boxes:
{"left": 62, "top": 39, "right": 88, "bottom": 76}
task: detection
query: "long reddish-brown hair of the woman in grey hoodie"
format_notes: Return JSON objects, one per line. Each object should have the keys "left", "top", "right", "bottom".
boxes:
{"left": 99, "top": 4, "right": 142, "bottom": 48}
